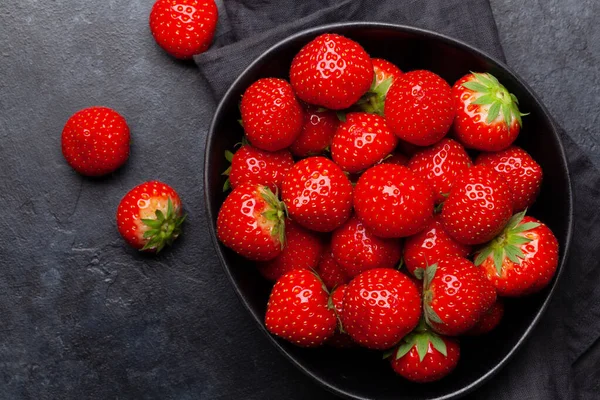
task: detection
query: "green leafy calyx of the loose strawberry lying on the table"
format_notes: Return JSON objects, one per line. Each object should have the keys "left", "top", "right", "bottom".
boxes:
{"left": 141, "top": 197, "right": 187, "bottom": 253}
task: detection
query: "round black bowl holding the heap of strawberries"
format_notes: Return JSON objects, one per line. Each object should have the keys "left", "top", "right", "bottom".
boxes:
{"left": 204, "top": 23, "right": 572, "bottom": 400}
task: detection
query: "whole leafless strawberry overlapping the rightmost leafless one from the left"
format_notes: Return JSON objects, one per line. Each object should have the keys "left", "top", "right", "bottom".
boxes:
{"left": 442, "top": 165, "right": 512, "bottom": 244}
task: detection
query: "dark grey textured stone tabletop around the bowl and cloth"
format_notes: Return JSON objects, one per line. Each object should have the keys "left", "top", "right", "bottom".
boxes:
{"left": 0, "top": 0, "right": 600, "bottom": 399}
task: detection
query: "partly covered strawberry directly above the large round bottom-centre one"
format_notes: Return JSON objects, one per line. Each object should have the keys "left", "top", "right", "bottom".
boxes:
{"left": 331, "top": 217, "right": 402, "bottom": 277}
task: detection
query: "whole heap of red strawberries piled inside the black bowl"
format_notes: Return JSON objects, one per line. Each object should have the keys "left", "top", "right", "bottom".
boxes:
{"left": 217, "top": 34, "right": 558, "bottom": 382}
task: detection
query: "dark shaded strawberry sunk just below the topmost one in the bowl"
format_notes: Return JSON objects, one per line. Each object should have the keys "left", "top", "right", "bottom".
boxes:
{"left": 290, "top": 106, "right": 339, "bottom": 157}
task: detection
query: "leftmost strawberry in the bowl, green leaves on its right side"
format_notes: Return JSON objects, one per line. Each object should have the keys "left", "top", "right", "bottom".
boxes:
{"left": 217, "top": 183, "right": 285, "bottom": 261}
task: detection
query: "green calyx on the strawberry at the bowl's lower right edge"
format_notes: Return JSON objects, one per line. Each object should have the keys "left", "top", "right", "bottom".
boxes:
{"left": 474, "top": 210, "right": 540, "bottom": 276}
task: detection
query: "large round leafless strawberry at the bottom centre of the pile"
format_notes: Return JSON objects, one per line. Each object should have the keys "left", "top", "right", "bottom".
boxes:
{"left": 341, "top": 268, "right": 421, "bottom": 349}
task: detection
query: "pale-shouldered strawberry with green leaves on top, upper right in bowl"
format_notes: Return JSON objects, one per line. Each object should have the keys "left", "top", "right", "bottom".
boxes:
{"left": 452, "top": 73, "right": 523, "bottom": 151}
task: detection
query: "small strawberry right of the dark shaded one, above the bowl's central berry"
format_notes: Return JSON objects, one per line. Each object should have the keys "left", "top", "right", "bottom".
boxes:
{"left": 331, "top": 112, "right": 398, "bottom": 173}
